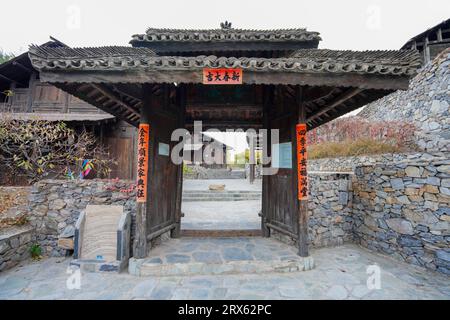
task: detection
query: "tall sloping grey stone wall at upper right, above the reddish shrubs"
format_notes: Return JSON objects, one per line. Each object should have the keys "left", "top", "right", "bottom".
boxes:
{"left": 358, "top": 49, "right": 450, "bottom": 152}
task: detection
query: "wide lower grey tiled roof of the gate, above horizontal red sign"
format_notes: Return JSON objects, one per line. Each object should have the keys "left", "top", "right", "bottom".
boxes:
{"left": 29, "top": 46, "right": 420, "bottom": 76}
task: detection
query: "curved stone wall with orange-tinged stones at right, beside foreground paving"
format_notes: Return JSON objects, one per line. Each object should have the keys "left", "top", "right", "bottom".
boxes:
{"left": 353, "top": 159, "right": 450, "bottom": 274}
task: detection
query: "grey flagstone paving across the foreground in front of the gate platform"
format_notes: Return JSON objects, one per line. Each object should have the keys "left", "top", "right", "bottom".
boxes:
{"left": 0, "top": 244, "right": 450, "bottom": 300}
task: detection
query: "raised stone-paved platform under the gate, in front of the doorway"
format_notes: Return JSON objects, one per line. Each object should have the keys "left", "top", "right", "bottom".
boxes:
{"left": 128, "top": 237, "right": 314, "bottom": 277}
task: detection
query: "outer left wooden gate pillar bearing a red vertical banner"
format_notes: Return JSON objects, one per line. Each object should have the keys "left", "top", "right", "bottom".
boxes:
{"left": 133, "top": 85, "right": 152, "bottom": 259}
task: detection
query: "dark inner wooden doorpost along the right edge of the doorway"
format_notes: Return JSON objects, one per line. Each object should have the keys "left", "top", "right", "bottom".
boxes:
{"left": 261, "top": 85, "right": 273, "bottom": 237}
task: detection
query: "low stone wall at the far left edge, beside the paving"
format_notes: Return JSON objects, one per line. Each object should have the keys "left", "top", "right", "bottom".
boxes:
{"left": 0, "top": 227, "right": 33, "bottom": 272}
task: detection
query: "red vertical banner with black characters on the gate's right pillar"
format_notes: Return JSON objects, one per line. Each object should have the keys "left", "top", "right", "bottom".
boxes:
{"left": 295, "top": 123, "right": 308, "bottom": 200}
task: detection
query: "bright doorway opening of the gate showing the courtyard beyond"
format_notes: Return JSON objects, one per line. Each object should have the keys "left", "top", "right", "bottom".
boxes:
{"left": 181, "top": 132, "right": 262, "bottom": 237}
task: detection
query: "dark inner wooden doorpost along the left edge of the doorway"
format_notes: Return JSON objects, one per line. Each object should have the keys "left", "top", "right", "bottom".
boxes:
{"left": 171, "top": 85, "right": 186, "bottom": 238}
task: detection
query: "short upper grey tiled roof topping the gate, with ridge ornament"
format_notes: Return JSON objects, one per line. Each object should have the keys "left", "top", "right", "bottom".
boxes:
{"left": 130, "top": 28, "right": 321, "bottom": 43}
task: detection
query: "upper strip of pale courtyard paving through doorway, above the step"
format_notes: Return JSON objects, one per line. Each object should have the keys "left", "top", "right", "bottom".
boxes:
{"left": 183, "top": 179, "right": 262, "bottom": 191}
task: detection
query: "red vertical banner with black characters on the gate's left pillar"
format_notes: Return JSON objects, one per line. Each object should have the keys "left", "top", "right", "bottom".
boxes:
{"left": 136, "top": 124, "right": 150, "bottom": 202}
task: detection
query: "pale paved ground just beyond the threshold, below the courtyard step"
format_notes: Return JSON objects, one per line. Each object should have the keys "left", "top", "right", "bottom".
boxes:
{"left": 181, "top": 200, "right": 261, "bottom": 230}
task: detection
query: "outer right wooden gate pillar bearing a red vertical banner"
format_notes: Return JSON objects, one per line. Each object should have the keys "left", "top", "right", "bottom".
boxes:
{"left": 292, "top": 86, "right": 309, "bottom": 257}
